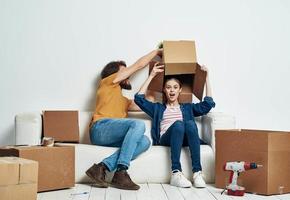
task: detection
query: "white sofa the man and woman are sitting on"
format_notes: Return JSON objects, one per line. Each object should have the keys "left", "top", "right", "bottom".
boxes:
{"left": 15, "top": 112, "right": 235, "bottom": 183}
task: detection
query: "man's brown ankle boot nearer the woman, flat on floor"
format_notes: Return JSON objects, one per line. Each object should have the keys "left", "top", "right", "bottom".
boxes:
{"left": 111, "top": 170, "right": 140, "bottom": 190}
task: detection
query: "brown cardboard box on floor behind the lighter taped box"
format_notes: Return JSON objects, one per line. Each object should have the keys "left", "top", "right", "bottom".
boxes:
{"left": 0, "top": 146, "right": 75, "bottom": 192}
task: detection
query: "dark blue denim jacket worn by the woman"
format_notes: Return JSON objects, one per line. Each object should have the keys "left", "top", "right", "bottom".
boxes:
{"left": 134, "top": 93, "right": 215, "bottom": 145}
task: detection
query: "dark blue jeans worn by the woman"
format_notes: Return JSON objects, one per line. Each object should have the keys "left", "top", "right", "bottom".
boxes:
{"left": 160, "top": 121, "right": 201, "bottom": 172}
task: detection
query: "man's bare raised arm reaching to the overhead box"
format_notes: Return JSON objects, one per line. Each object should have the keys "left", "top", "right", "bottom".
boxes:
{"left": 113, "top": 49, "right": 162, "bottom": 83}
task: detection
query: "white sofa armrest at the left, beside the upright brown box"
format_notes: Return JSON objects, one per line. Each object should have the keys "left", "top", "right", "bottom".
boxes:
{"left": 15, "top": 112, "right": 42, "bottom": 145}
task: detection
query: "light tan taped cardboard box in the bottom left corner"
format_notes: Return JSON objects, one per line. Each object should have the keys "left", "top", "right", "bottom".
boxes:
{"left": 0, "top": 157, "right": 38, "bottom": 200}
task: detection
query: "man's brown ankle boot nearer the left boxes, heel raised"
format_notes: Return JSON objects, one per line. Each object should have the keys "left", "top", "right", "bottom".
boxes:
{"left": 86, "top": 163, "right": 108, "bottom": 188}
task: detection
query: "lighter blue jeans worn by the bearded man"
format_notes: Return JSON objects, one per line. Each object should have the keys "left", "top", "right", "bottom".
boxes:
{"left": 90, "top": 119, "right": 150, "bottom": 171}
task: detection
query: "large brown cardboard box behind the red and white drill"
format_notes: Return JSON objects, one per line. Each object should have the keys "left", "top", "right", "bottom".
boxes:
{"left": 215, "top": 129, "right": 290, "bottom": 195}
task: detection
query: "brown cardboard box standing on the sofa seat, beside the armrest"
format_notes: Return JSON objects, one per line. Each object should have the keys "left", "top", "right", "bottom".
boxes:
{"left": 43, "top": 111, "right": 79, "bottom": 142}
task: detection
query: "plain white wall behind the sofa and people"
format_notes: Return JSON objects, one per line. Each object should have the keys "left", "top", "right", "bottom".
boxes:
{"left": 0, "top": 0, "right": 290, "bottom": 145}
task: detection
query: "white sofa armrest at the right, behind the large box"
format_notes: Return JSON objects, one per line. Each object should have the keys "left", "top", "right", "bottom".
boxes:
{"left": 202, "top": 112, "right": 236, "bottom": 152}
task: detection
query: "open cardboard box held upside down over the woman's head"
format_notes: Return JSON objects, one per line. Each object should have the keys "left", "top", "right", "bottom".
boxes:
{"left": 148, "top": 41, "right": 206, "bottom": 103}
